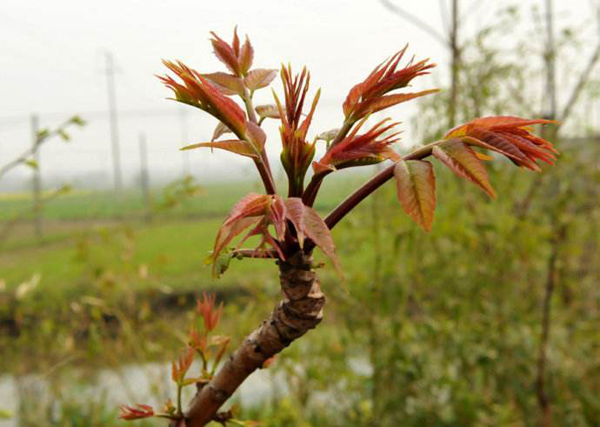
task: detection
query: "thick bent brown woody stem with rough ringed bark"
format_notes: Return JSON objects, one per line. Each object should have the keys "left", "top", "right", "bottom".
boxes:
{"left": 185, "top": 251, "right": 325, "bottom": 427}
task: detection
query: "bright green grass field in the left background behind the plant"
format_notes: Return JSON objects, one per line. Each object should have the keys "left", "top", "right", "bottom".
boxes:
{"left": 0, "top": 175, "right": 364, "bottom": 300}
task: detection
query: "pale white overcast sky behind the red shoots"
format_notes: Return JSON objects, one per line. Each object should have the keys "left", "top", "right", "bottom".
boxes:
{"left": 0, "top": 0, "right": 590, "bottom": 191}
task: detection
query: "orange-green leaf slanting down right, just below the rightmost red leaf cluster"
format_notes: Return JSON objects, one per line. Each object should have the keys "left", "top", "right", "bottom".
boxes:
{"left": 432, "top": 139, "right": 496, "bottom": 198}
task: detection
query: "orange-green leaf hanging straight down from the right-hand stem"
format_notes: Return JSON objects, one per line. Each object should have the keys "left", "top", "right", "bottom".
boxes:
{"left": 394, "top": 160, "right": 435, "bottom": 231}
